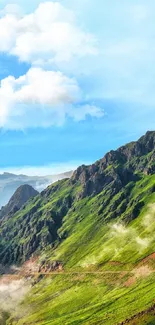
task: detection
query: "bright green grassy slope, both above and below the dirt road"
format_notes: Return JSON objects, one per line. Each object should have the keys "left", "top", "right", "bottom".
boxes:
{"left": 8, "top": 176, "right": 155, "bottom": 325}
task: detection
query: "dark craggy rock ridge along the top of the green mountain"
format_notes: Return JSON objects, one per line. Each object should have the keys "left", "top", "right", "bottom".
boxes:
{"left": 0, "top": 131, "right": 155, "bottom": 262}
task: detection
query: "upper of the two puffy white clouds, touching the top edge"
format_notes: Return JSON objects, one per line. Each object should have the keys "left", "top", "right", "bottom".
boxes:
{"left": 0, "top": 2, "right": 97, "bottom": 65}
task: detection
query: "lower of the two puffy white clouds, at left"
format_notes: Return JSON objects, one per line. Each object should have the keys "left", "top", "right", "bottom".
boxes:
{"left": 0, "top": 67, "right": 103, "bottom": 129}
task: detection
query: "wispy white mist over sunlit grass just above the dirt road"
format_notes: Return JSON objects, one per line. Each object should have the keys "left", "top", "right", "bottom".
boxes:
{"left": 80, "top": 204, "right": 155, "bottom": 267}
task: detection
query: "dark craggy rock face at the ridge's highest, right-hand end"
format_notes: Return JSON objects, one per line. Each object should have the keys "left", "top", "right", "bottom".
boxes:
{"left": 70, "top": 131, "right": 155, "bottom": 199}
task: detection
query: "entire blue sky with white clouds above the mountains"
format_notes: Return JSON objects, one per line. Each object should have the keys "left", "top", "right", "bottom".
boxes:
{"left": 0, "top": 0, "right": 155, "bottom": 175}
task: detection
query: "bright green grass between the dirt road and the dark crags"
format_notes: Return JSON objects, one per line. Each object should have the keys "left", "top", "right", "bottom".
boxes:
{"left": 41, "top": 175, "right": 155, "bottom": 268}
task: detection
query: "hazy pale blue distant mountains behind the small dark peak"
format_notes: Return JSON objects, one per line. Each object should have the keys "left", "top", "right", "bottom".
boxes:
{"left": 0, "top": 171, "right": 73, "bottom": 208}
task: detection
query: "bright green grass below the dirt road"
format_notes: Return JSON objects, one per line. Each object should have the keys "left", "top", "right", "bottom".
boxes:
{"left": 8, "top": 274, "right": 155, "bottom": 325}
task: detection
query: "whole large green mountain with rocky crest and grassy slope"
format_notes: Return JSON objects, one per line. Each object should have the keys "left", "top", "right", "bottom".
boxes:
{"left": 0, "top": 131, "right": 155, "bottom": 325}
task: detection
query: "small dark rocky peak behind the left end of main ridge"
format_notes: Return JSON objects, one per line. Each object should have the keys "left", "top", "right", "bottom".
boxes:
{"left": 0, "top": 185, "right": 39, "bottom": 218}
